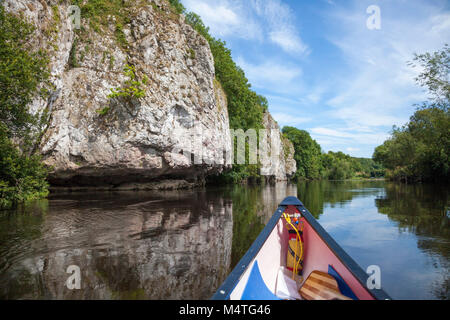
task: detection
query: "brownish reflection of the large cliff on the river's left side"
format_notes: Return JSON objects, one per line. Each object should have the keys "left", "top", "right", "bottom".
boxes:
{"left": 0, "top": 191, "right": 233, "bottom": 299}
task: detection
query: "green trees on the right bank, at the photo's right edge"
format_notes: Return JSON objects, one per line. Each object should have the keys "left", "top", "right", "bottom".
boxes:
{"left": 373, "top": 45, "right": 450, "bottom": 182}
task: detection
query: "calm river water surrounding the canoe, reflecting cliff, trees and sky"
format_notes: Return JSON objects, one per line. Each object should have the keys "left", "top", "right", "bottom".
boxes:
{"left": 0, "top": 181, "right": 450, "bottom": 299}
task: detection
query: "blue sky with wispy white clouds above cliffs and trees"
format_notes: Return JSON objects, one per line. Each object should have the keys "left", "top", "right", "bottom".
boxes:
{"left": 182, "top": 0, "right": 450, "bottom": 157}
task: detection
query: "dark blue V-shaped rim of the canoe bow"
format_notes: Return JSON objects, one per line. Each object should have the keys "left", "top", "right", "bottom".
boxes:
{"left": 211, "top": 197, "right": 391, "bottom": 300}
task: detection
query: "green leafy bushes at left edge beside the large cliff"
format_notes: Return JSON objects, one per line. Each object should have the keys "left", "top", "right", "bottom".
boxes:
{"left": 0, "top": 5, "right": 49, "bottom": 208}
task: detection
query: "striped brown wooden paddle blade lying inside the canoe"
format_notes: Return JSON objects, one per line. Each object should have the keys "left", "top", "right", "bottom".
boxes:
{"left": 299, "top": 271, "right": 353, "bottom": 300}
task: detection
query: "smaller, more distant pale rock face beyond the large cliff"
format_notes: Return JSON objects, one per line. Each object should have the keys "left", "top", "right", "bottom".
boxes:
{"left": 261, "top": 112, "right": 297, "bottom": 181}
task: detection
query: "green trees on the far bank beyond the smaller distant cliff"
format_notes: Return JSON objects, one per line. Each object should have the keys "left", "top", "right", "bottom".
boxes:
{"left": 283, "top": 127, "right": 384, "bottom": 180}
